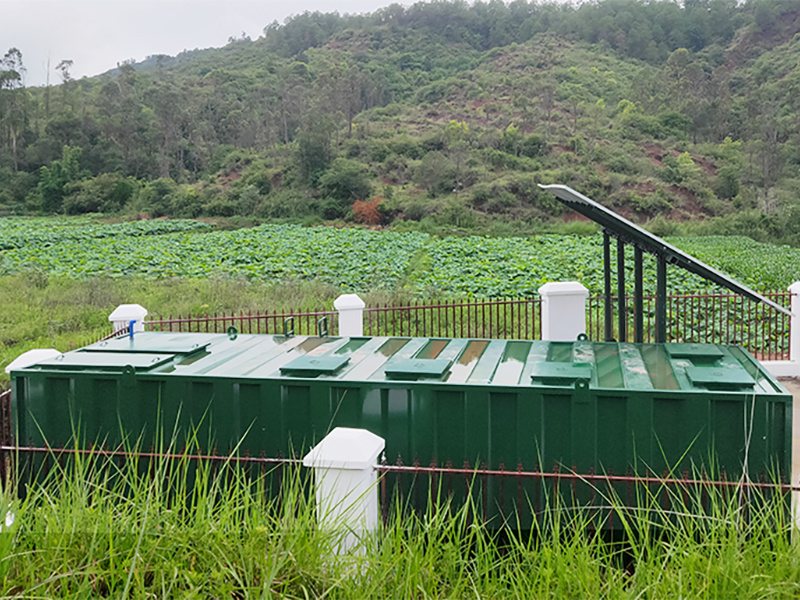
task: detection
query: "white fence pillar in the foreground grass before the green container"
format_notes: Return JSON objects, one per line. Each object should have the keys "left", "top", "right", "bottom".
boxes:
{"left": 303, "top": 427, "right": 386, "bottom": 554}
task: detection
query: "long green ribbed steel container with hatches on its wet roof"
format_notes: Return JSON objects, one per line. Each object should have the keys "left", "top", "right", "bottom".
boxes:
{"left": 11, "top": 333, "right": 791, "bottom": 488}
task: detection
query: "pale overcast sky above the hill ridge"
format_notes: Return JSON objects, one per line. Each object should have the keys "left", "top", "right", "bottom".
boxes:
{"left": 0, "top": 0, "right": 412, "bottom": 86}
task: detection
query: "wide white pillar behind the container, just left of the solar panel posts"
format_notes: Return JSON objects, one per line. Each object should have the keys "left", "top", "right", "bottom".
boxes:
{"left": 539, "top": 281, "right": 589, "bottom": 342}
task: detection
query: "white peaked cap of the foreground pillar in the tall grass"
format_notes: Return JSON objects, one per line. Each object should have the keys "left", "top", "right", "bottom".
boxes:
{"left": 303, "top": 427, "right": 386, "bottom": 471}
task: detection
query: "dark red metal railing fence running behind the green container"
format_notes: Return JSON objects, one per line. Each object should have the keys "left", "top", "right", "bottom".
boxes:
{"left": 145, "top": 292, "right": 791, "bottom": 360}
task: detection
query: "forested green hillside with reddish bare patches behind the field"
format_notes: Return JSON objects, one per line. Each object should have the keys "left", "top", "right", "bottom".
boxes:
{"left": 0, "top": 0, "right": 800, "bottom": 243}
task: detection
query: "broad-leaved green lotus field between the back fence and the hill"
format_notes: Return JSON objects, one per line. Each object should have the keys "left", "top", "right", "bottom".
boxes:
{"left": 0, "top": 218, "right": 800, "bottom": 298}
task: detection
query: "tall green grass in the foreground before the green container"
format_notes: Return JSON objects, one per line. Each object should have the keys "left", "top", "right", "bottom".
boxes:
{"left": 0, "top": 438, "right": 800, "bottom": 599}
